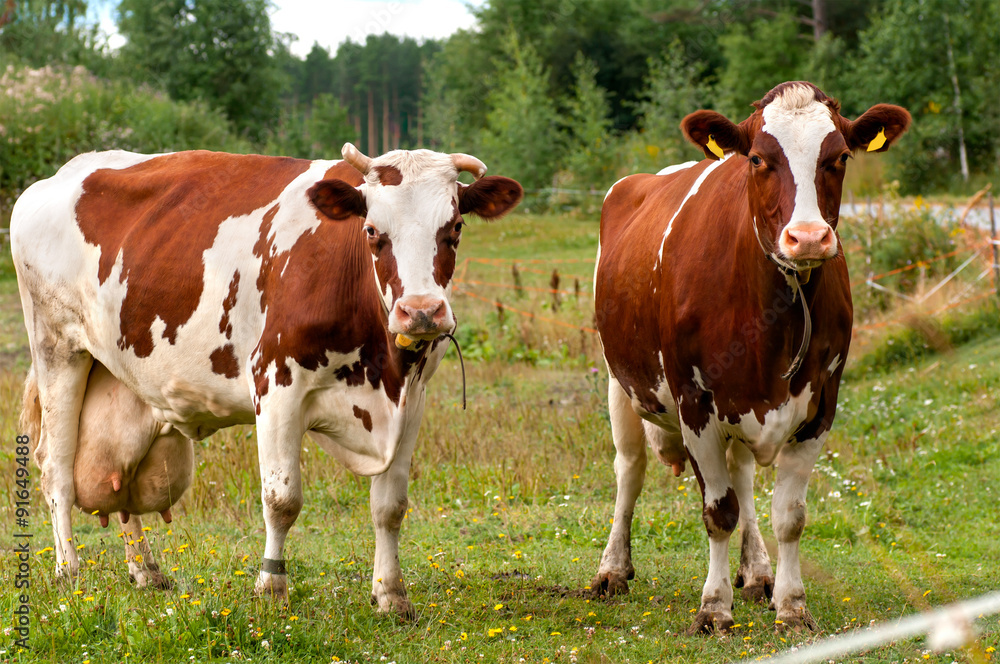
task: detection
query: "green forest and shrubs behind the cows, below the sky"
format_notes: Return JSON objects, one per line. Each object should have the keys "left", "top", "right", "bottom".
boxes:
{"left": 0, "top": 0, "right": 1000, "bottom": 217}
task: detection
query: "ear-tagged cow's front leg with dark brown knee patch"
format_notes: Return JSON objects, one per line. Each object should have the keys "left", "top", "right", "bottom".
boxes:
{"left": 684, "top": 427, "right": 740, "bottom": 634}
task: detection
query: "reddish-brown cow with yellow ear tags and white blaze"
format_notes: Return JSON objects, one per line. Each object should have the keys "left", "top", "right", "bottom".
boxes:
{"left": 591, "top": 82, "right": 910, "bottom": 632}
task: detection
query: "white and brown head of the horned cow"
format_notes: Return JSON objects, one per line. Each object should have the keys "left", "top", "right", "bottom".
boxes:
{"left": 308, "top": 143, "right": 523, "bottom": 341}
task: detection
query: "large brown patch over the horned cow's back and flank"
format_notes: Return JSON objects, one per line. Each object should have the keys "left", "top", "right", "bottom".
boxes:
{"left": 76, "top": 151, "right": 309, "bottom": 357}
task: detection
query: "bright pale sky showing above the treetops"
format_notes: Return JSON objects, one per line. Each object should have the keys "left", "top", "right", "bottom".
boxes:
{"left": 98, "top": 0, "right": 486, "bottom": 57}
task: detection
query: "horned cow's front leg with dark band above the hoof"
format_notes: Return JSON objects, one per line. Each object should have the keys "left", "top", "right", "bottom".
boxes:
{"left": 254, "top": 406, "right": 303, "bottom": 601}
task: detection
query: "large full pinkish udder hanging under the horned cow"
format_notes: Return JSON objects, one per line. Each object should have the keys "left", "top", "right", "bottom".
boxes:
{"left": 73, "top": 362, "right": 194, "bottom": 514}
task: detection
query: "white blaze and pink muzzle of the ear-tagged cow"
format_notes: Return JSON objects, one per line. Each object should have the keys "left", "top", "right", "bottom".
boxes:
{"left": 762, "top": 86, "right": 839, "bottom": 270}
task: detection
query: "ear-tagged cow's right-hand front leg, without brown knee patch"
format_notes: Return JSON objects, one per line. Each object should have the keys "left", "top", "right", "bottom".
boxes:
{"left": 771, "top": 435, "right": 826, "bottom": 632}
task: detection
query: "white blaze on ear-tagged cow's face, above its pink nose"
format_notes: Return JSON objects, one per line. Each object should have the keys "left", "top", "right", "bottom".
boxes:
{"left": 762, "top": 86, "right": 837, "bottom": 227}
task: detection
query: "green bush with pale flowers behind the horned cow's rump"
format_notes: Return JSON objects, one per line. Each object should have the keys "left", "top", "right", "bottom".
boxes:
{"left": 0, "top": 65, "right": 251, "bottom": 225}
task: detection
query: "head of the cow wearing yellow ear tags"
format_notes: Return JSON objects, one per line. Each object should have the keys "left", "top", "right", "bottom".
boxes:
{"left": 681, "top": 81, "right": 910, "bottom": 271}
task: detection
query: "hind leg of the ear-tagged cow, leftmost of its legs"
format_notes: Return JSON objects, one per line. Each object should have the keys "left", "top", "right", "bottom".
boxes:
{"left": 590, "top": 377, "right": 646, "bottom": 595}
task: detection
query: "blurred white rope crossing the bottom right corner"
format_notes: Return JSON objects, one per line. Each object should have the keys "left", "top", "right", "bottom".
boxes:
{"left": 743, "top": 591, "right": 1000, "bottom": 664}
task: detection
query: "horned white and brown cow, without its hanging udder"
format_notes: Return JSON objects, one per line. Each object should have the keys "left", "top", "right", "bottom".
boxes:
{"left": 11, "top": 144, "right": 522, "bottom": 616}
